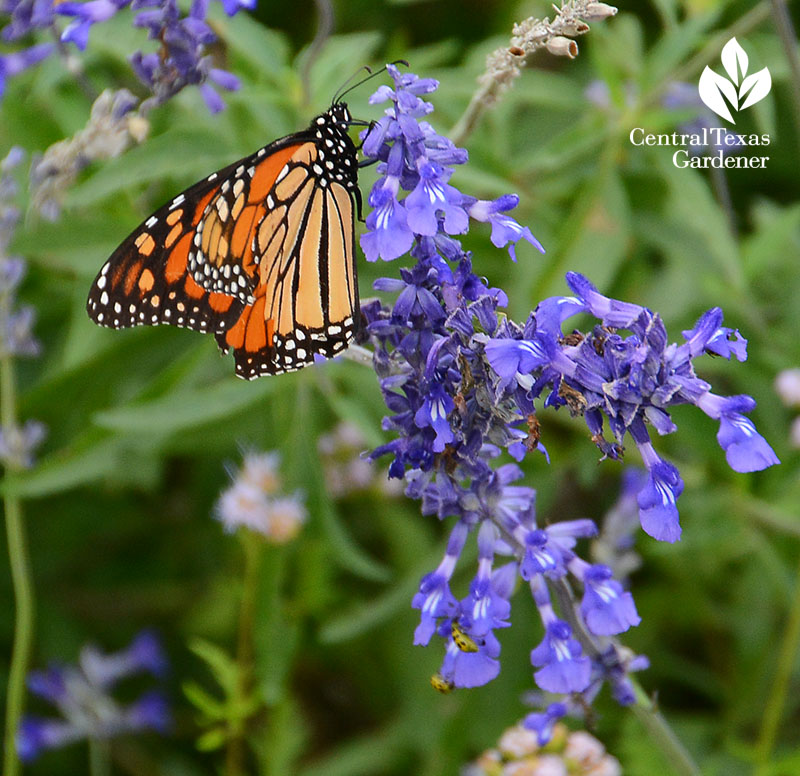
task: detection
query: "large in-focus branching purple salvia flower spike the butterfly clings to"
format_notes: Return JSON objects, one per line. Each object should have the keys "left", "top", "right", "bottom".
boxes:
{"left": 362, "top": 66, "right": 776, "bottom": 728}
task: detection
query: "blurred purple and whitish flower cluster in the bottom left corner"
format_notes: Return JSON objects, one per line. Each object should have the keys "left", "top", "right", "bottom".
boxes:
{"left": 16, "top": 631, "right": 170, "bottom": 762}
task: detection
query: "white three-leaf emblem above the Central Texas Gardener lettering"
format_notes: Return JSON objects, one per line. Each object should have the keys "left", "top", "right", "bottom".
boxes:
{"left": 698, "top": 38, "right": 772, "bottom": 124}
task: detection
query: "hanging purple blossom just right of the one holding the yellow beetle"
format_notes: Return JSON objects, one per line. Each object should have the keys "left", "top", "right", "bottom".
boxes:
{"left": 531, "top": 620, "right": 592, "bottom": 693}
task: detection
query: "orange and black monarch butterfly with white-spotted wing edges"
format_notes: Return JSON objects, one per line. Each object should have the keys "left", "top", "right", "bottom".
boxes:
{"left": 86, "top": 98, "right": 361, "bottom": 380}
